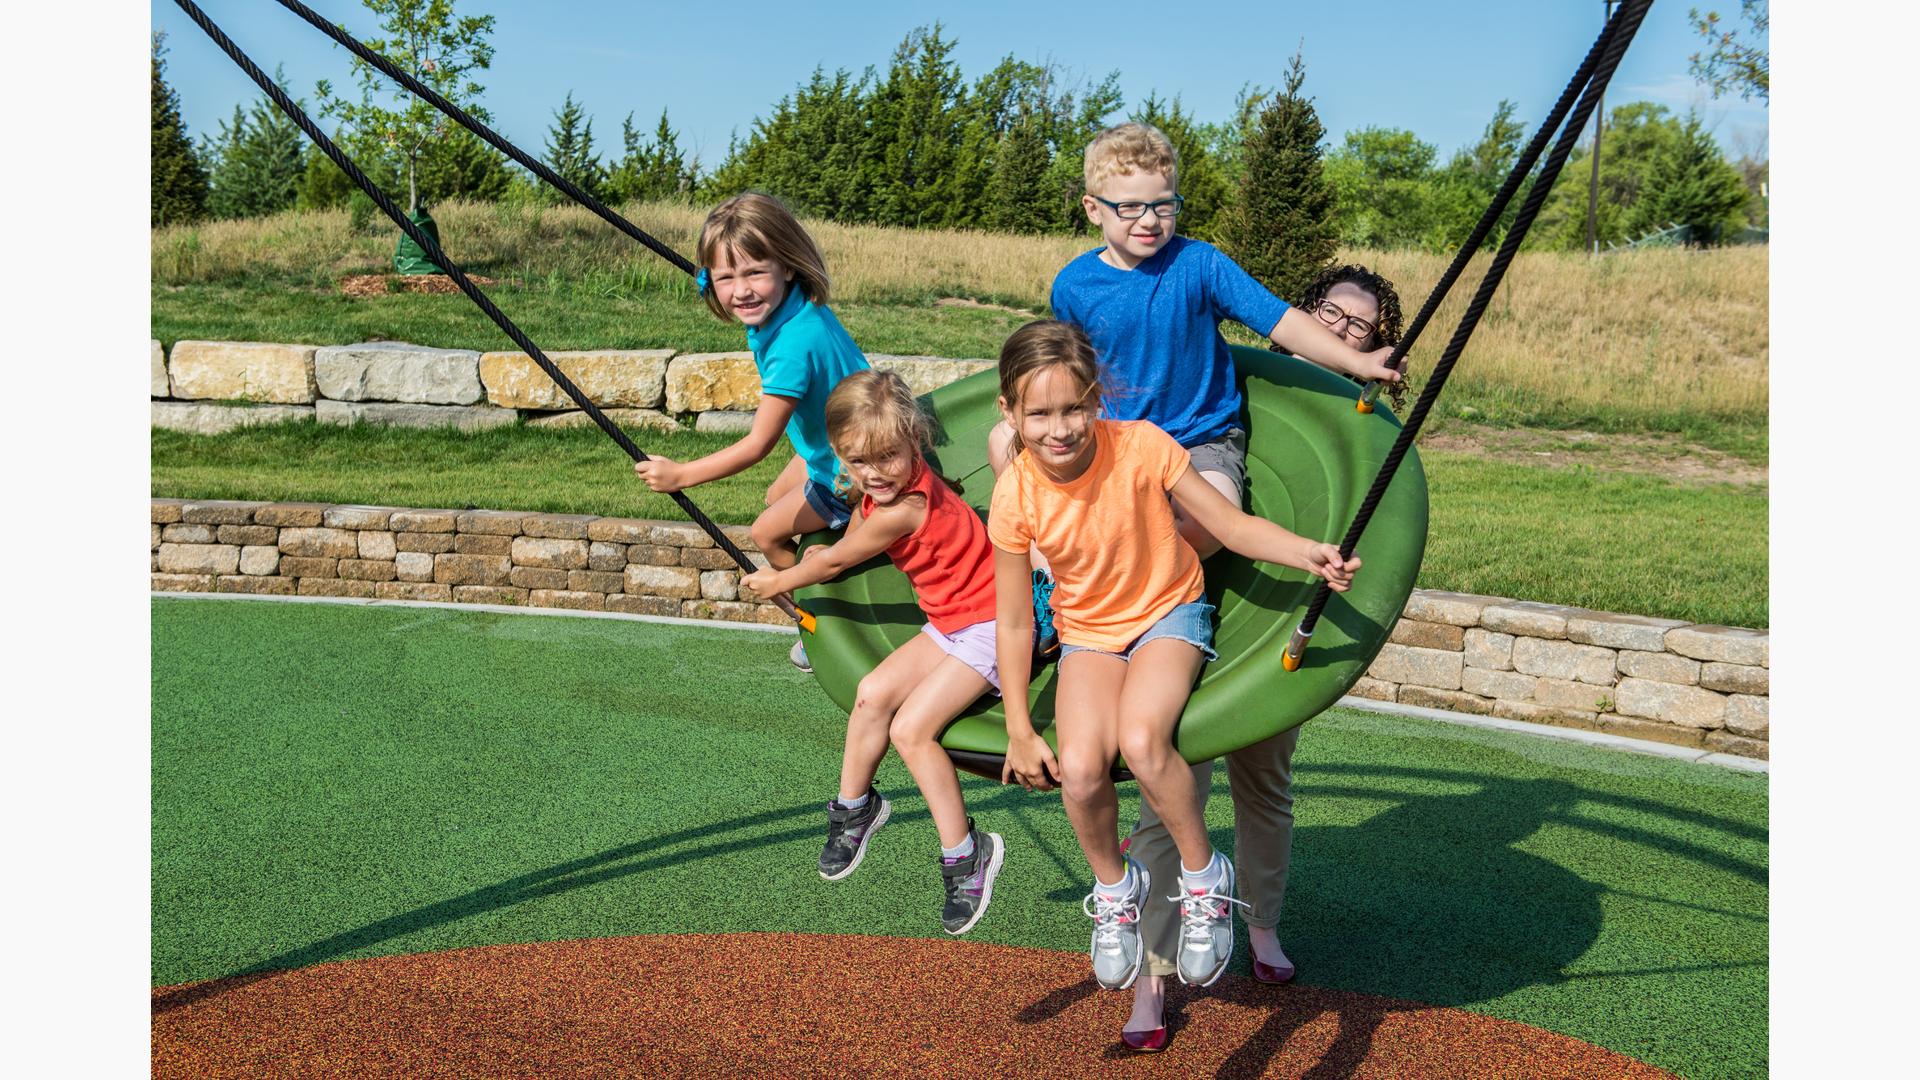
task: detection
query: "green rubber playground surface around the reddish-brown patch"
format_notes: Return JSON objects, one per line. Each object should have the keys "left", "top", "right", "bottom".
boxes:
{"left": 152, "top": 600, "right": 1768, "bottom": 1076}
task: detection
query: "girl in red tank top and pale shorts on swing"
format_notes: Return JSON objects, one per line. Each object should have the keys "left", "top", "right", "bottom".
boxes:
{"left": 739, "top": 371, "right": 1006, "bottom": 934}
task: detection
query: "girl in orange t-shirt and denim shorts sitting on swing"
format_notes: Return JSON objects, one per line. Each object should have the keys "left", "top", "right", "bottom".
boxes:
{"left": 989, "top": 321, "right": 1359, "bottom": 1014}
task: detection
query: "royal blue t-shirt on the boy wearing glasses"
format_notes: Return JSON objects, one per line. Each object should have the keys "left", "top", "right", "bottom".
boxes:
{"left": 1052, "top": 234, "right": 1286, "bottom": 446}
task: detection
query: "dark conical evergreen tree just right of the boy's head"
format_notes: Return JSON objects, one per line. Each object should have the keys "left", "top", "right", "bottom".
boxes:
{"left": 1221, "top": 52, "right": 1336, "bottom": 298}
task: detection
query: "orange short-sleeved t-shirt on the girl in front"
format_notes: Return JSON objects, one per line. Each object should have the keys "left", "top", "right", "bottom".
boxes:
{"left": 987, "top": 421, "right": 1206, "bottom": 651}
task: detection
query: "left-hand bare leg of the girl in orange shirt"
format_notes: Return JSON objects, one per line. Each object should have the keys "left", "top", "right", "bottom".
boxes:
{"left": 1054, "top": 651, "right": 1127, "bottom": 882}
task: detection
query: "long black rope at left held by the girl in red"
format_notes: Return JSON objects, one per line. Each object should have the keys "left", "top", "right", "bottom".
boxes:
{"left": 175, "top": 0, "right": 814, "bottom": 630}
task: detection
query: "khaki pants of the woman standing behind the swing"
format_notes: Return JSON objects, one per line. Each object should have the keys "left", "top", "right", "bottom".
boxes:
{"left": 1127, "top": 726, "right": 1300, "bottom": 976}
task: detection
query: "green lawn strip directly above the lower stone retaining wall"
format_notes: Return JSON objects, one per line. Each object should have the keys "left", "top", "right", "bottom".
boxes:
{"left": 150, "top": 423, "right": 1768, "bottom": 628}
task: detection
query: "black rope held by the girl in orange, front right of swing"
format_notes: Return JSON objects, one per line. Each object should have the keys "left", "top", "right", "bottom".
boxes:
{"left": 1281, "top": 0, "right": 1653, "bottom": 671}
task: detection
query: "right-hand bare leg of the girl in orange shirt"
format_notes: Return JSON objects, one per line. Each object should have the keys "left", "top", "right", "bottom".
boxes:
{"left": 1117, "top": 638, "right": 1213, "bottom": 871}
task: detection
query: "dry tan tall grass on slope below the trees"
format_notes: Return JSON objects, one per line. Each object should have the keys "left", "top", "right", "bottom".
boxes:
{"left": 152, "top": 204, "right": 1768, "bottom": 421}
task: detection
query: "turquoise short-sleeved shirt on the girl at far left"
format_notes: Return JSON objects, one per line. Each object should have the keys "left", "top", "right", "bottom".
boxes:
{"left": 747, "top": 288, "right": 868, "bottom": 488}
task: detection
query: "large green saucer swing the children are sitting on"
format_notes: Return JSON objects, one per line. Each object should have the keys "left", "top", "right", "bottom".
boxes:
{"left": 797, "top": 346, "right": 1427, "bottom": 778}
